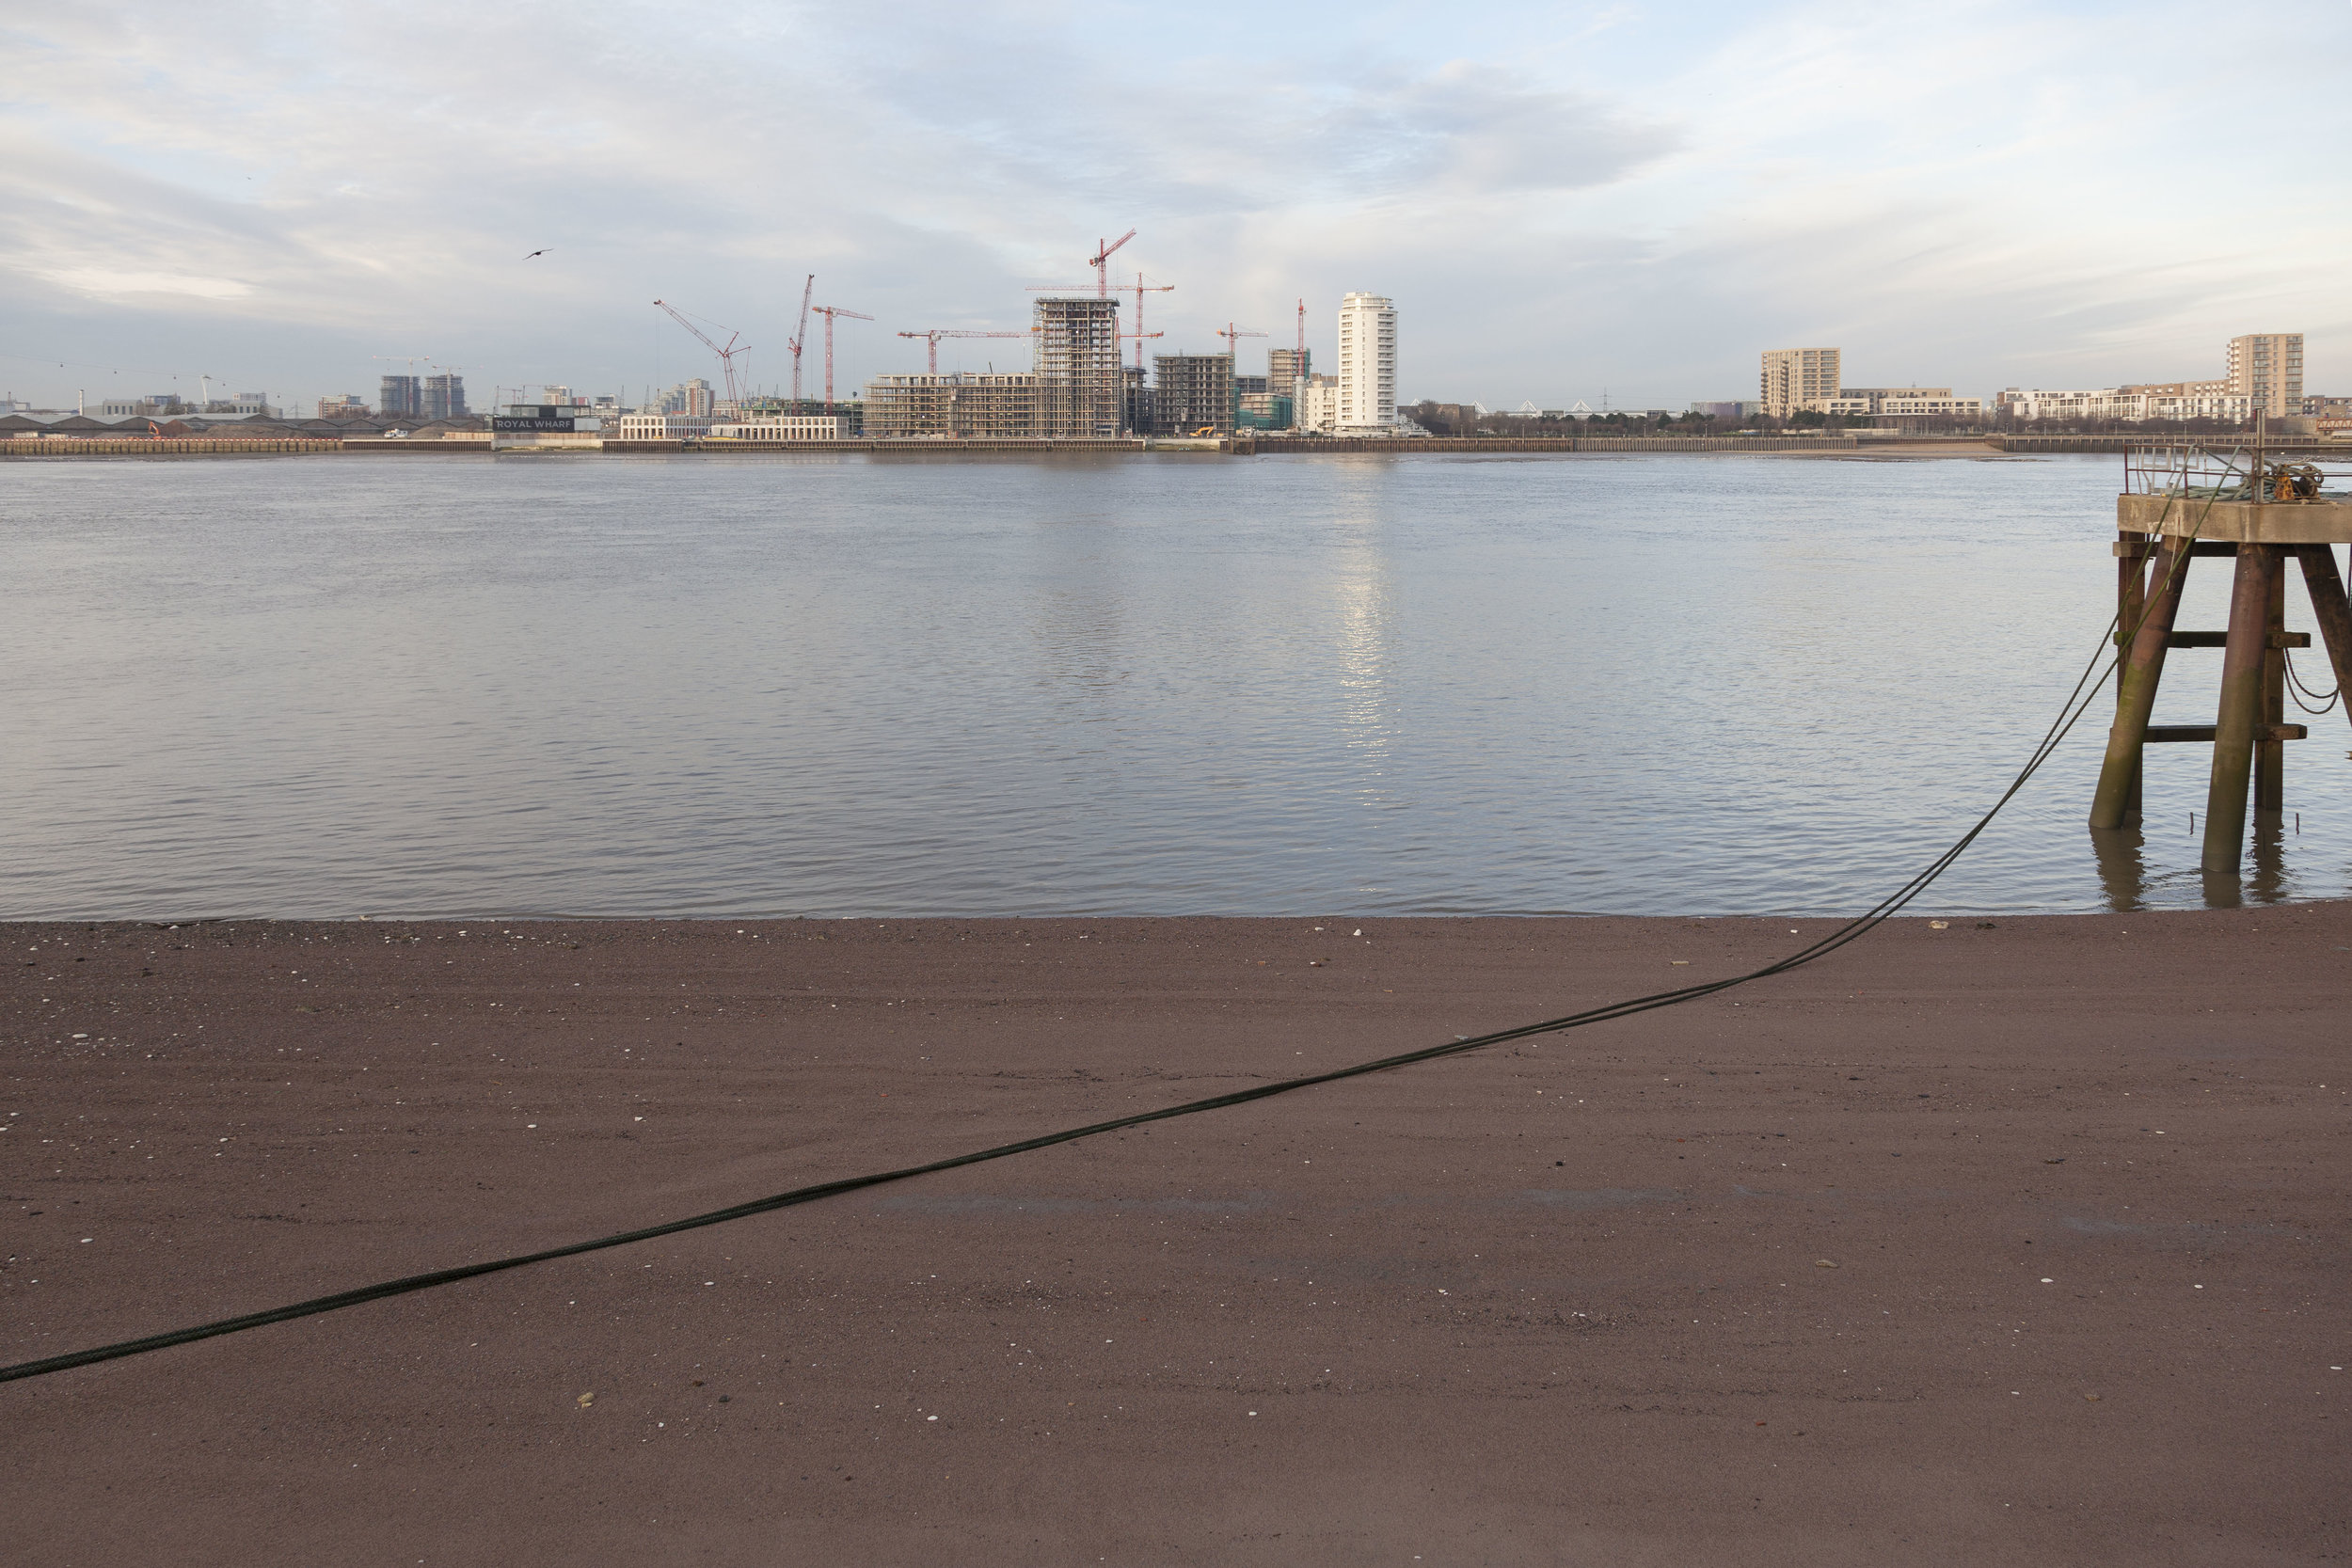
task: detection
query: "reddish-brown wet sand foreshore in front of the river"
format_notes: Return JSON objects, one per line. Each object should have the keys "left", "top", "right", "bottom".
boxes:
{"left": 0, "top": 905, "right": 2352, "bottom": 1568}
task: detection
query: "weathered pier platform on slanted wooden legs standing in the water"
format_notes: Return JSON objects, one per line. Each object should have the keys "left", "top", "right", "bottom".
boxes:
{"left": 2091, "top": 437, "right": 2352, "bottom": 875}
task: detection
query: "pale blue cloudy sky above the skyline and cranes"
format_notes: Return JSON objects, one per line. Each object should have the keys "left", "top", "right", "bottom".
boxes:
{"left": 0, "top": 0, "right": 2352, "bottom": 411}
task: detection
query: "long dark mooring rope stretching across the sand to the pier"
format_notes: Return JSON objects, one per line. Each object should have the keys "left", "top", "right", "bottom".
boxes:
{"left": 0, "top": 486, "right": 2214, "bottom": 1383}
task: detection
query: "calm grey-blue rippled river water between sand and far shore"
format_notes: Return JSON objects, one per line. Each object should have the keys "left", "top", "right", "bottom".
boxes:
{"left": 0, "top": 453, "right": 2352, "bottom": 917}
